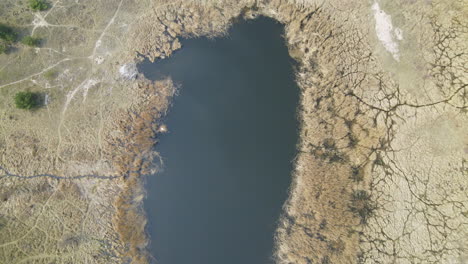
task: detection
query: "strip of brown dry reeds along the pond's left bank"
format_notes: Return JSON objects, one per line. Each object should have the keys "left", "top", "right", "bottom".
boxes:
{"left": 108, "top": 79, "right": 175, "bottom": 264}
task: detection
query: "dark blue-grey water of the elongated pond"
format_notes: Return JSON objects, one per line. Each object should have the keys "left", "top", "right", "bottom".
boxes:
{"left": 139, "top": 18, "right": 299, "bottom": 264}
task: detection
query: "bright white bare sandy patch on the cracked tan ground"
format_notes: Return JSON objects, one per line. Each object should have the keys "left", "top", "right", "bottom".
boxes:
{"left": 372, "top": 2, "right": 403, "bottom": 61}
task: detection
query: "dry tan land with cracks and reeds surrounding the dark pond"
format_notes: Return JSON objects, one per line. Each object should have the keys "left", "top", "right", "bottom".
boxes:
{"left": 0, "top": 0, "right": 468, "bottom": 263}
